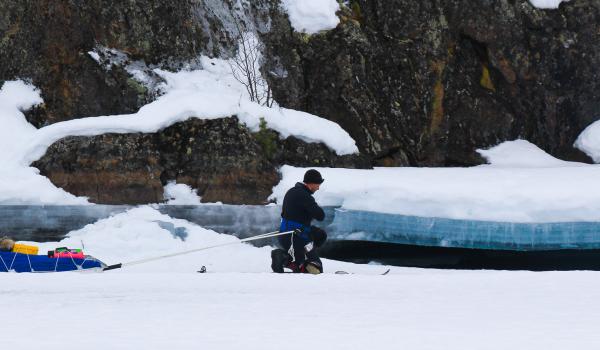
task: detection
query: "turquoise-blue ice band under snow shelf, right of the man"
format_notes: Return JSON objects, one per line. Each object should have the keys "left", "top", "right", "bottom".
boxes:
{"left": 329, "top": 210, "right": 600, "bottom": 250}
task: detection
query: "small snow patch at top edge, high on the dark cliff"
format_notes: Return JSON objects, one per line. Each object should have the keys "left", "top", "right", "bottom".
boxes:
{"left": 282, "top": 0, "right": 340, "bottom": 34}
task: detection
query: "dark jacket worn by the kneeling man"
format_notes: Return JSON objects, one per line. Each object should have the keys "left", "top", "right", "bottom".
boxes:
{"left": 281, "top": 182, "right": 325, "bottom": 229}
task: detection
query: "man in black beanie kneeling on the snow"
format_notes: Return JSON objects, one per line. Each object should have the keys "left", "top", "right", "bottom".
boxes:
{"left": 271, "top": 169, "right": 327, "bottom": 274}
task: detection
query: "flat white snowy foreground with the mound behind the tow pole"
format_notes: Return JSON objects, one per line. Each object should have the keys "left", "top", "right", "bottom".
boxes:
{"left": 0, "top": 207, "right": 600, "bottom": 350}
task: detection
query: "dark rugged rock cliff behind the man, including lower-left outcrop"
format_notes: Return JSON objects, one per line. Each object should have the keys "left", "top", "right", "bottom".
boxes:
{"left": 0, "top": 0, "right": 600, "bottom": 203}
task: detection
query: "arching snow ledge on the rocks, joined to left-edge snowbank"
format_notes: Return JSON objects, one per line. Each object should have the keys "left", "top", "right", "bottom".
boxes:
{"left": 0, "top": 50, "right": 358, "bottom": 204}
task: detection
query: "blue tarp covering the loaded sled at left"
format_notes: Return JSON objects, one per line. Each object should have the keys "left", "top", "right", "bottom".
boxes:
{"left": 0, "top": 252, "right": 106, "bottom": 272}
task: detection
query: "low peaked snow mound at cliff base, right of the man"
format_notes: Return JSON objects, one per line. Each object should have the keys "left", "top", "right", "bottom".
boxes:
{"left": 477, "top": 140, "right": 587, "bottom": 168}
